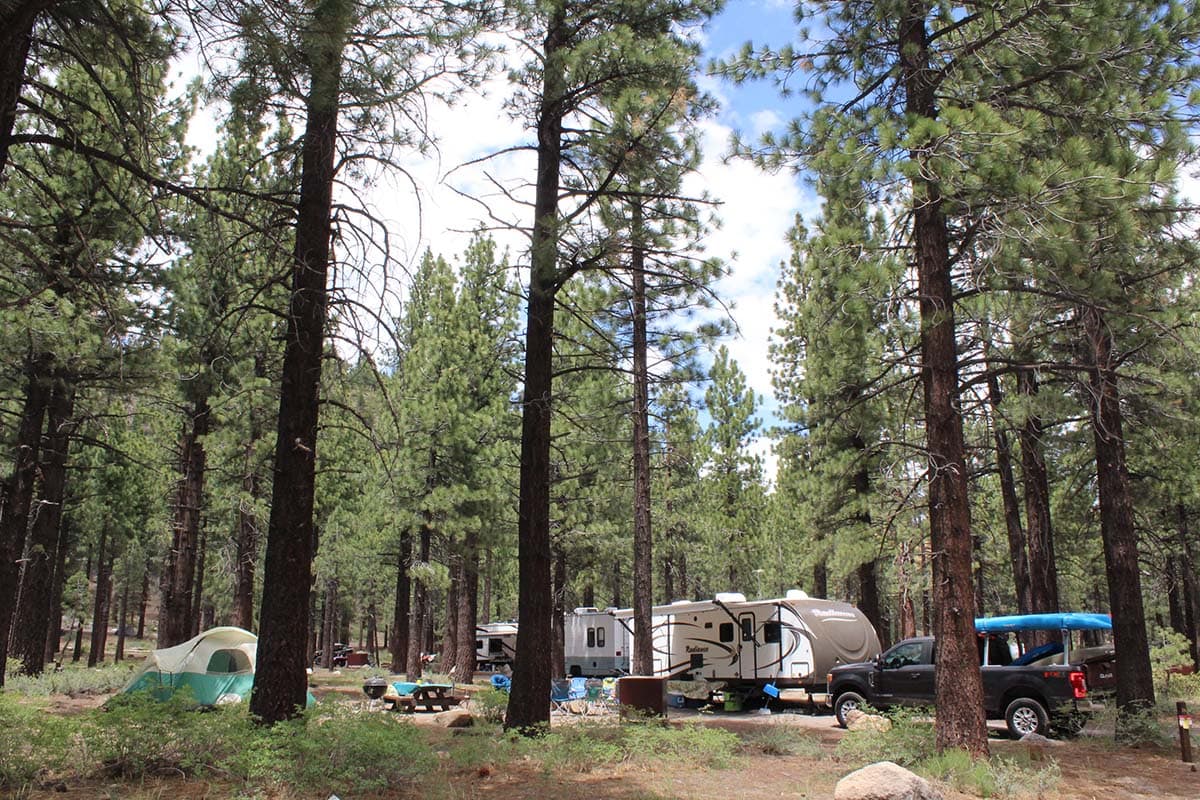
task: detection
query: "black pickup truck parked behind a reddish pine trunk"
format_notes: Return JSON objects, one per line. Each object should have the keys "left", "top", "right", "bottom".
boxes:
{"left": 829, "top": 637, "right": 1090, "bottom": 738}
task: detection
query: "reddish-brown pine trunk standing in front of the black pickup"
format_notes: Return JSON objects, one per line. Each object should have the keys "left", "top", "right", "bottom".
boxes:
{"left": 899, "top": 0, "right": 988, "bottom": 756}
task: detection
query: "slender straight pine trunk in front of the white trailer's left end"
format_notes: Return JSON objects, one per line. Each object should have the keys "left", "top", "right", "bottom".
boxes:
{"left": 630, "top": 205, "right": 654, "bottom": 675}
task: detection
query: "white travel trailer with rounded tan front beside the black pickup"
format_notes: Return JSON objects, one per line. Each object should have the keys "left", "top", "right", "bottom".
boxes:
{"left": 614, "top": 589, "right": 881, "bottom": 693}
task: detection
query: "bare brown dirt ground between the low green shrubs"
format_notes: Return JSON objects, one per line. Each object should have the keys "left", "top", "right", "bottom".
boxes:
{"left": 14, "top": 686, "right": 1200, "bottom": 800}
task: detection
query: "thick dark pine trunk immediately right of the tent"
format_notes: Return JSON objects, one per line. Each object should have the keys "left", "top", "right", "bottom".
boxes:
{"left": 250, "top": 0, "right": 352, "bottom": 724}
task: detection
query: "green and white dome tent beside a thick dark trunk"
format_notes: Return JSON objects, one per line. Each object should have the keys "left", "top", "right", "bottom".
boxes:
{"left": 124, "top": 627, "right": 258, "bottom": 705}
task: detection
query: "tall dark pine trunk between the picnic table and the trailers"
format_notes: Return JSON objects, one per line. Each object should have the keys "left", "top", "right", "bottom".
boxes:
{"left": 504, "top": 2, "right": 568, "bottom": 734}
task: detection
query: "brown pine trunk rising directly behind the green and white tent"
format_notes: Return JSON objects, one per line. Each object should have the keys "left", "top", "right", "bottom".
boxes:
{"left": 158, "top": 396, "right": 211, "bottom": 648}
